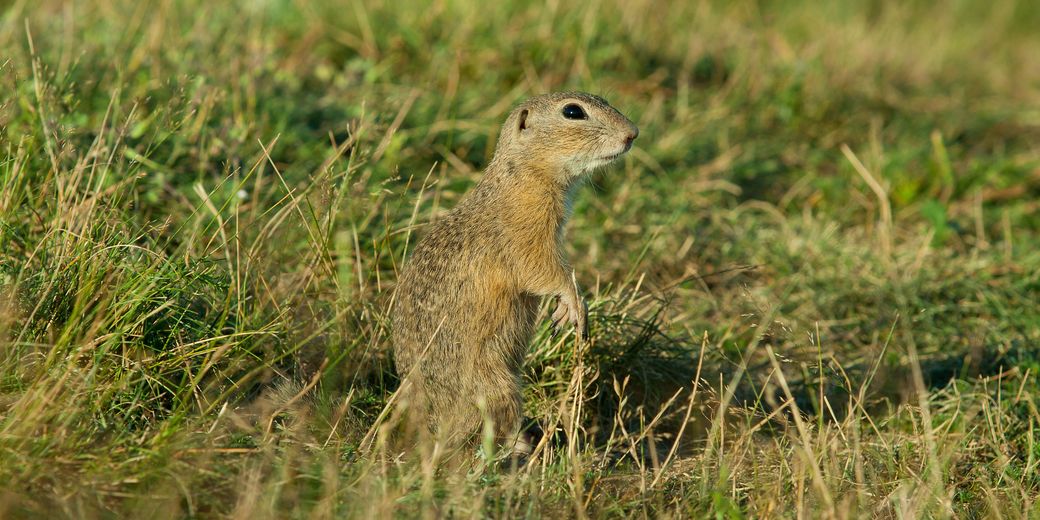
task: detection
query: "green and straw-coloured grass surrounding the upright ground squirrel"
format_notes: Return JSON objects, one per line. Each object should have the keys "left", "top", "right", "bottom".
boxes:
{"left": 0, "top": 0, "right": 1040, "bottom": 518}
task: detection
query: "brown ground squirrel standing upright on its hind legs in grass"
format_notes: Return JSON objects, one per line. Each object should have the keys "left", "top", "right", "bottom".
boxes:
{"left": 392, "top": 93, "right": 639, "bottom": 454}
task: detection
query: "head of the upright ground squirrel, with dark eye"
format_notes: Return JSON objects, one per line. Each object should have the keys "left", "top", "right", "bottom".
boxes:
{"left": 495, "top": 92, "right": 640, "bottom": 180}
